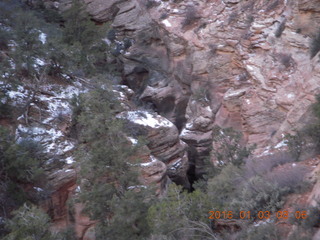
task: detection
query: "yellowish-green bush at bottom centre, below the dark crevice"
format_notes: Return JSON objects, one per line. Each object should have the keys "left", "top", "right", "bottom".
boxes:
{"left": 148, "top": 184, "right": 214, "bottom": 239}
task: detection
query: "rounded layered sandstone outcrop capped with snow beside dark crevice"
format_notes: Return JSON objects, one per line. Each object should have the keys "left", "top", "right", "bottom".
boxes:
{"left": 119, "top": 111, "right": 190, "bottom": 188}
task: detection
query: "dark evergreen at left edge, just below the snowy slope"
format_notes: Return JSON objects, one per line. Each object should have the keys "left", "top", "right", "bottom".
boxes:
{"left": 0, "top": 127, "right": 46, "bottom": 223}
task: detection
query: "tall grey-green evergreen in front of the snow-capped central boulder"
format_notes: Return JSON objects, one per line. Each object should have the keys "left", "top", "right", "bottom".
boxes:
{"left": 76, "top": 89, "right": 149, "bottom": 240}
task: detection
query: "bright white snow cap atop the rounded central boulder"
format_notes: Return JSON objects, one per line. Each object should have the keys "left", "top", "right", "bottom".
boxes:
{"left": 118, "top": 111, "right": 174, "bottom": 128}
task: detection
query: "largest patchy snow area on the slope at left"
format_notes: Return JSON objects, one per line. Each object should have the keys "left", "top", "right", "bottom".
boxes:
{"left": 9, "top": 83, "right": 87, "bottom": 164}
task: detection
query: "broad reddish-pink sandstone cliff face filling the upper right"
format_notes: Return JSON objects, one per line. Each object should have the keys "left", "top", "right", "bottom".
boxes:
{"left": 96, "top": 0, "right": 320, "bottom": 157}
